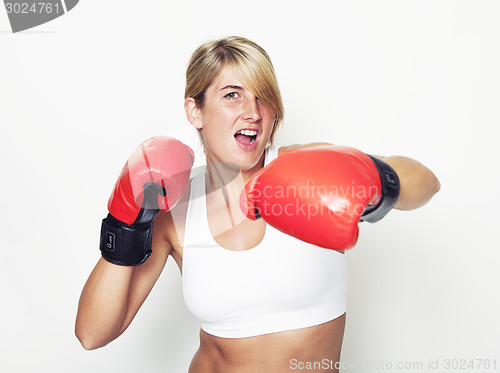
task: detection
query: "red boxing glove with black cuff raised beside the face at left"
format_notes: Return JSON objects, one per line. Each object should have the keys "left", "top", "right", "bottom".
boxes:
{"left": 100, "top": 136, "right": 194, "bottom": 266}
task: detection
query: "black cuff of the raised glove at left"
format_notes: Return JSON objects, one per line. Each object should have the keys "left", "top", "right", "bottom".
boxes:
{"left": 99, "top": 214, "right": 153, "bottom": 266}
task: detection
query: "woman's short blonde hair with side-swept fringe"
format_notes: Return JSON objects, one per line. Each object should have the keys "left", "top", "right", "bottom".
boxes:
{"left": 184, "top": 36, "right": 284, "bottom": 144}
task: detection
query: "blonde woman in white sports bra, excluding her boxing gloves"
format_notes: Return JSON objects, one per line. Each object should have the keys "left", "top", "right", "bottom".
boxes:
{"left": 76, "top": 37, "right": 439, "bottom": 373}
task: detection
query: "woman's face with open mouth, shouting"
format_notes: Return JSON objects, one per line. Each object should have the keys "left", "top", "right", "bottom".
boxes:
{"left": 188, "top": 66, "right": 275, "bottom": 171}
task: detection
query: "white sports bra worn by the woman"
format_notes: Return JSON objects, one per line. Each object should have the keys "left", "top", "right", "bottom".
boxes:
{"left": 182, "top": 147, "right": 346, "bottom": 338}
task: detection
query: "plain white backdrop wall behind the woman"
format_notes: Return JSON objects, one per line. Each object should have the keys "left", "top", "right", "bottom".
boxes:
{"left": 0, "top": 0, "right": 500, "bottom": 373}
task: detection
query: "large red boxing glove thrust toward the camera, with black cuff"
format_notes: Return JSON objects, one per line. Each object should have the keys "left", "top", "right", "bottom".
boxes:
{"left": 241, "top": 145, "right": 399, "bottom": 250}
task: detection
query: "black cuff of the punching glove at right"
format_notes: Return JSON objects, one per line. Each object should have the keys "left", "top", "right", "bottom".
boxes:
{"left": 361, "top": 155, "right": 400, "bottom": 223}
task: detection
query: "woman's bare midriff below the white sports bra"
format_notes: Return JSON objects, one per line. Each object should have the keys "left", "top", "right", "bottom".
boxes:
{"left": 189, "top": 314, "right": 345, "bottom": 373}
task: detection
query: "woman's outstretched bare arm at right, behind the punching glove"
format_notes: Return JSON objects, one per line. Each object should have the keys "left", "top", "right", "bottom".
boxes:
{"left": 278, "top": 142, "right": 441, "bottom": 210}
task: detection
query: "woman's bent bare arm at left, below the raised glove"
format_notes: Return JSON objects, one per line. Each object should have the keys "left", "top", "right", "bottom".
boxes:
{"left": 75, "top": 213, "right": 172, "bottom": 350}
